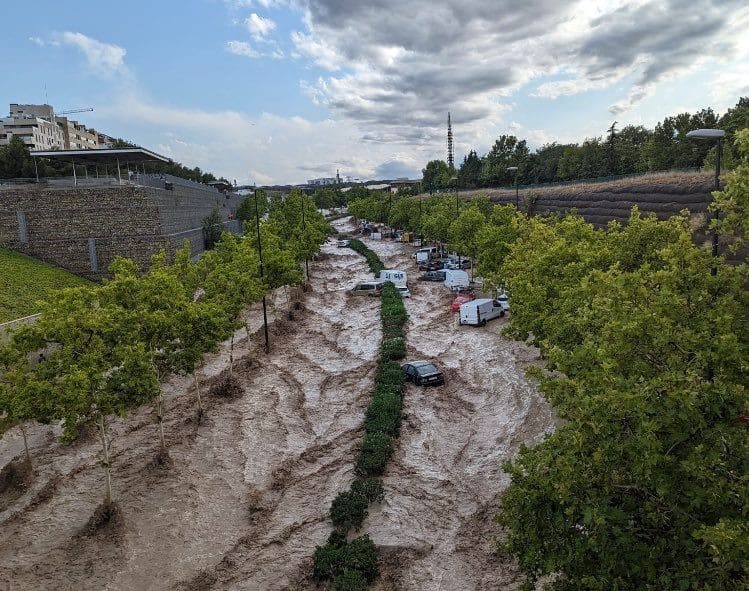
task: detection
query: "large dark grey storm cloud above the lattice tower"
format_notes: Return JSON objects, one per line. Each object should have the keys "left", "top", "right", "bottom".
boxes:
{"left": 295, "top": 0, "right": 745, "bottom": 143}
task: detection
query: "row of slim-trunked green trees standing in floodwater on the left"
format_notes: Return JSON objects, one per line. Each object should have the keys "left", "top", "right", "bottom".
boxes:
{"left": 0, "top": 193, "right": 329, "bottom": 504}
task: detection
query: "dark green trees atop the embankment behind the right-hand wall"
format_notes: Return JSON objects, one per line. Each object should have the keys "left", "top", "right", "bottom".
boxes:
{"left": 422, "top": 97, "right": 749, "bottom": 191}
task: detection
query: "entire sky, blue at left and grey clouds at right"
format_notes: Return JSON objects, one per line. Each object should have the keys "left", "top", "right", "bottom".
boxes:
{"left": 0, "top": 0, "right": 749, "bottom": 184}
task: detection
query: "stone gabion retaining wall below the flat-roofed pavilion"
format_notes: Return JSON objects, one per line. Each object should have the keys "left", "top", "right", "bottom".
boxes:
{"left": 0, "top": 178, "right": 242, "bottom": 279}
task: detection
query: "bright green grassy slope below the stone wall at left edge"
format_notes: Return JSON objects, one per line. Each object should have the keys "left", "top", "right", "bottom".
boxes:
{"left": 0, "top": 247, "right": 91, "bottom": 322}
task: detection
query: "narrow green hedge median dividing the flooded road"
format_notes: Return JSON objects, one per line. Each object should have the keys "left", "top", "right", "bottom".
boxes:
{"left": 314, "top": 240, "right": 407, "bottom": 591}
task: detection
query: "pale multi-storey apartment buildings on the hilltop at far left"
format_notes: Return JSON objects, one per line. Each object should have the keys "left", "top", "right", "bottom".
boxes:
{"left": 0, "top": 103, "right": 115, "bottom": 151}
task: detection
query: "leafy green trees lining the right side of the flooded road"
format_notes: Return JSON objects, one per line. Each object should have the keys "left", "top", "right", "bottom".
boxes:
{"left": 350, "top": 129, "right": 749, "bottom": 591}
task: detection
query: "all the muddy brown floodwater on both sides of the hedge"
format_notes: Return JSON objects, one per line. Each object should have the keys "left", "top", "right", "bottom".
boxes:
{"left": 0, "top": 219, "right": 553, "bottom": 591}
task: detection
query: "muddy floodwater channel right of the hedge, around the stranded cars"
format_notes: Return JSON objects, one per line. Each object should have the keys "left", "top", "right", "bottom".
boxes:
{"left": 363, "top": 235, "right": 554, "bottom": 591}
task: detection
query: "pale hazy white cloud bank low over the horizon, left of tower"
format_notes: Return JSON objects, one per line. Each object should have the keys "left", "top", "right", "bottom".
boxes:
{"left": 97, "top": 93, "right": 435, "bottom": 183}
